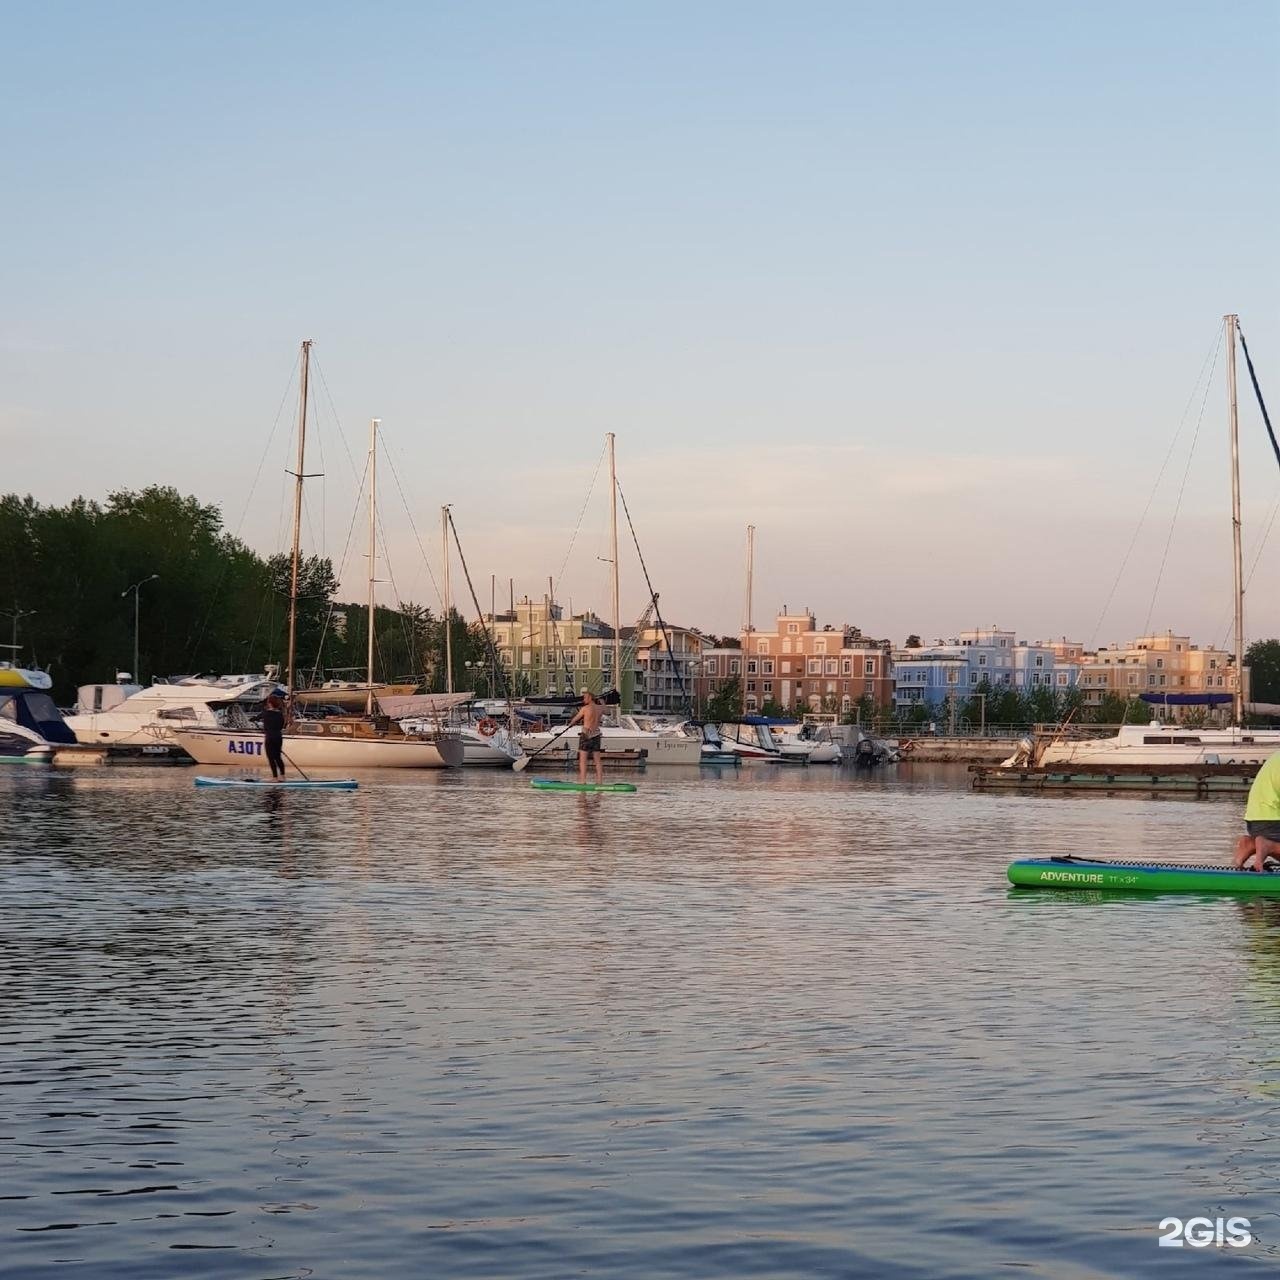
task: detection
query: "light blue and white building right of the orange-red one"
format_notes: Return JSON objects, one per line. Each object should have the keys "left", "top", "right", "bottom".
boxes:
{"left": 893, "top": 627, "right": 1083, "bottom": 710}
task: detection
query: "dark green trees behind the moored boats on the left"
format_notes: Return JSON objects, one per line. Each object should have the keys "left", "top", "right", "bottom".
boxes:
{"left": 0, "top": 485, "right": 488, "bottom": 704}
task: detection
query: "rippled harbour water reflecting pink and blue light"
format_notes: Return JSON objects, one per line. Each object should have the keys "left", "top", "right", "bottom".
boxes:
{"left": 0, "top": 765, "right": 1280, "bottom": 1280}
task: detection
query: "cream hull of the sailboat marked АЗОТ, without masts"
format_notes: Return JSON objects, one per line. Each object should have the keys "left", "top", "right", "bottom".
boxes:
{"left": 173, "top": 730, "right": 463, "bottom": 769}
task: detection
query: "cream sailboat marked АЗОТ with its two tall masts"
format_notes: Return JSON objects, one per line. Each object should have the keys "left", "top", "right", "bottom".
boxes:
{"left": 173, "top": 340, "right": 463, "bottom": 769}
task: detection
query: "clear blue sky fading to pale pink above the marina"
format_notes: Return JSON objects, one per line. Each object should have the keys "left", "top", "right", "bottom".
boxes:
{"left": 0, "top": 0, "right": 1280, "bottom": 644}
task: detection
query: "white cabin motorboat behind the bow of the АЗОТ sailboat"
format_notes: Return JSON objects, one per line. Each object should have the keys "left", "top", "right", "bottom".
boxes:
{"left": 67, "top": 676, "right": 276, "bottom": 755}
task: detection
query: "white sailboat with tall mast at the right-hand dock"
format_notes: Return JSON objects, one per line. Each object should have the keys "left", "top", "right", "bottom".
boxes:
{"left": 1034, "top": 315, "right": 1280, "bottom": 767}
